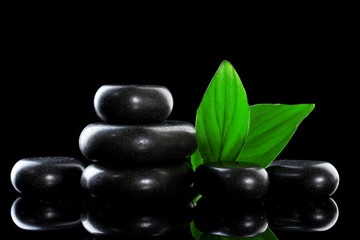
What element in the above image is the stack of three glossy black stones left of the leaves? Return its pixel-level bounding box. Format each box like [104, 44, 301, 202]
[79, 85, 196, 203]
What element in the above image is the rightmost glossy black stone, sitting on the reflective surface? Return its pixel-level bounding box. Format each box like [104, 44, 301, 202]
[266, 160, 339, 197]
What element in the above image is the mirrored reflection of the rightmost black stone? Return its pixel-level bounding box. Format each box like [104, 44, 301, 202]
[266, 198, 339, 232]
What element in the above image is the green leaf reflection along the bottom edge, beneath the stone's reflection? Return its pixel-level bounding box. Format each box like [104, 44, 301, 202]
[190, 224, 278, 240]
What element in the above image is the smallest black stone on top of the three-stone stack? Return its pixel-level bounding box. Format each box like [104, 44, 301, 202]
[94, 85, 173, 124]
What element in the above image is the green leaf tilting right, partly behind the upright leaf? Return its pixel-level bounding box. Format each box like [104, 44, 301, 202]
[236, 104, 315, 168]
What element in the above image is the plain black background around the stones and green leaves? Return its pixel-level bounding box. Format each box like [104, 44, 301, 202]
[1, 6, 358, 239]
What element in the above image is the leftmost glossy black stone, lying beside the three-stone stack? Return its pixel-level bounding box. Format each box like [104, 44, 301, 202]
[11, 157, 84, 197]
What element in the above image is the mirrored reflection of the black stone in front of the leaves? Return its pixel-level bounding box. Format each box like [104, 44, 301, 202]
[194, 198, 268, 238]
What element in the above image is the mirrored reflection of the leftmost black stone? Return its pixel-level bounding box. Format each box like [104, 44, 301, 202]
[11, 197, 80, 231]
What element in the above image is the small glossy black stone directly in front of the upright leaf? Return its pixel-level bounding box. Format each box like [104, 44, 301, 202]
[194, 162, 269, 201]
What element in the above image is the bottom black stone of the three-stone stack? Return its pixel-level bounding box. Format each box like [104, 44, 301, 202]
[81, 163, 193, 202]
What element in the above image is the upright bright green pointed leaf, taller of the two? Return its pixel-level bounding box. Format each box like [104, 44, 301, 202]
[195, 61, 250, 162]
